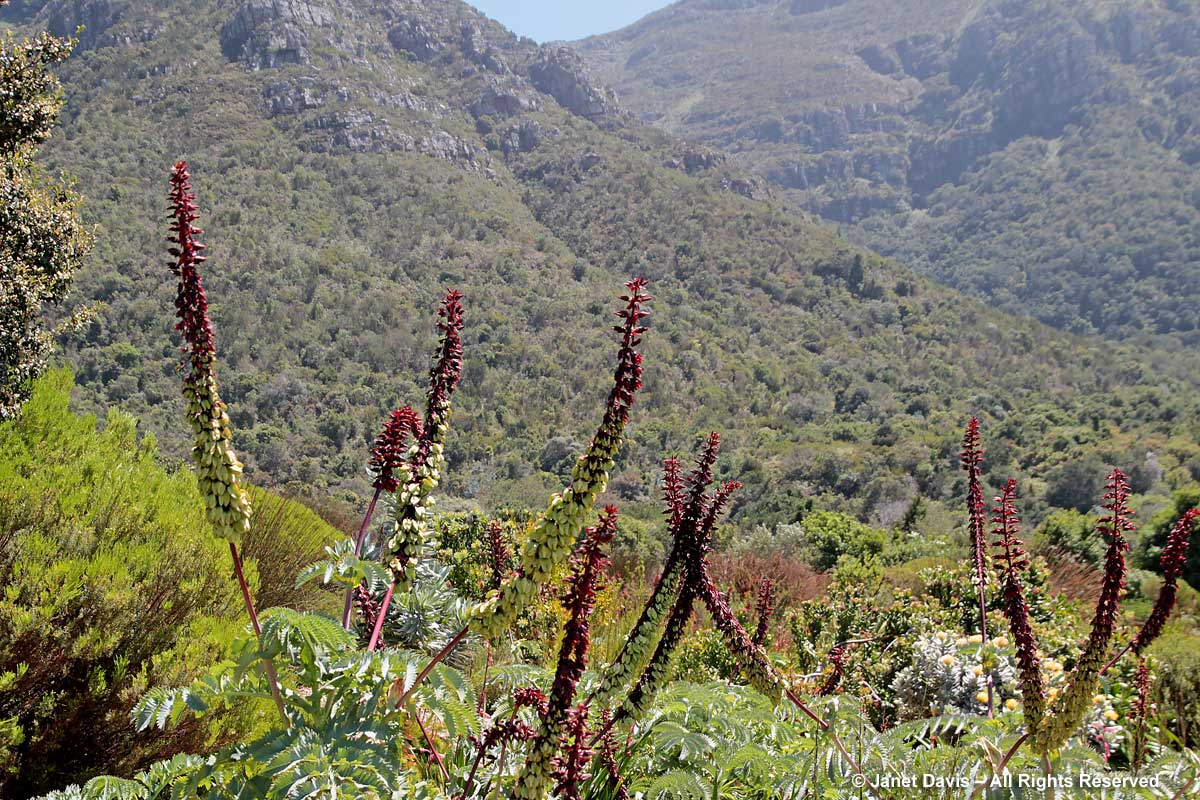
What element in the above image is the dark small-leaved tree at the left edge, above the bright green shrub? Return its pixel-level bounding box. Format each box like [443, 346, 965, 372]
[0, 7, 91, 420]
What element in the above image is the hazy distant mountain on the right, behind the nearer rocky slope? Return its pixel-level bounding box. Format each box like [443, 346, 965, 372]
[576, 0, 1200, 345]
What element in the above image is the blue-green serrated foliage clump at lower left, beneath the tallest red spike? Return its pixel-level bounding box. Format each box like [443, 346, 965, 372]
[60, 608, 465, 800]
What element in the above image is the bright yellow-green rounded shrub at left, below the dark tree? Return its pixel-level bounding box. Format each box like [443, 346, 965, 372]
[0, 371, 332, 796]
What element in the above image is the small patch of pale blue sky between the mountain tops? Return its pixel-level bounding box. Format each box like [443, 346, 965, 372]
[467, 0, 671, 42]
